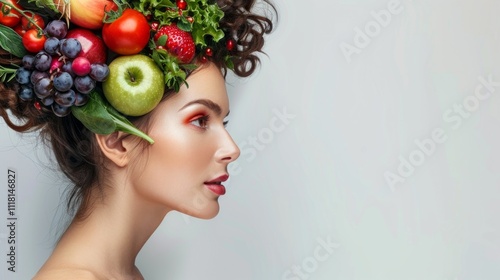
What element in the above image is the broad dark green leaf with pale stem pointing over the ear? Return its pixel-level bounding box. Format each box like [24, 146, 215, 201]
[71, 91, 154, 144]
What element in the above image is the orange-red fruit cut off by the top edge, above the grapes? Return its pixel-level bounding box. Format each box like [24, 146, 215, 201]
[54, 0, 118, 29]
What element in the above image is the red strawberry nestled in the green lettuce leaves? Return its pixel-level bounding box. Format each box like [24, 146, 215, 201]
[154, 23, 196, 63]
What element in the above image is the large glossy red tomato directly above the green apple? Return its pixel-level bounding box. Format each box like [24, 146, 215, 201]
[102, 9, 150, 55]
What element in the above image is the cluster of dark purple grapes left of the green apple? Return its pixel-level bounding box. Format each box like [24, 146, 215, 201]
[16, 20, 109, 117]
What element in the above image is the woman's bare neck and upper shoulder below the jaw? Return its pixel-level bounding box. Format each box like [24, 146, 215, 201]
[49, 175, 168, 279]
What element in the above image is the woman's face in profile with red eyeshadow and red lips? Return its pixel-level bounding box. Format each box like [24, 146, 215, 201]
[130, 64, 240, 219]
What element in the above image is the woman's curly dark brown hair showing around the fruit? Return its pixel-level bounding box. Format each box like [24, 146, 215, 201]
[0, 0, 277, 219]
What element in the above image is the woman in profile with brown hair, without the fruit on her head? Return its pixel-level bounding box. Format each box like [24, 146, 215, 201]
[0, 1, 272, 280]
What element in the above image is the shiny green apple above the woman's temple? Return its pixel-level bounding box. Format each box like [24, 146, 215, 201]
[102, 54, 165, 116]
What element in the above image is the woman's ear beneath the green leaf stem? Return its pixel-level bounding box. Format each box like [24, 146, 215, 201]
[95, 131, 132, 167]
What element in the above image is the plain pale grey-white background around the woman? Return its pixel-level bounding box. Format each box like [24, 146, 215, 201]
[0, 0, 500, 280]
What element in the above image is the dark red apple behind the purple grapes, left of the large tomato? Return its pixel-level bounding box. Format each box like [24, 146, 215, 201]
[66, 28, 107, 64]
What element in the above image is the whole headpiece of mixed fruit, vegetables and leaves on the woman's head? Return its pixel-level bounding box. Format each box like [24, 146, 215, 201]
[0, 0, 240, 143]
